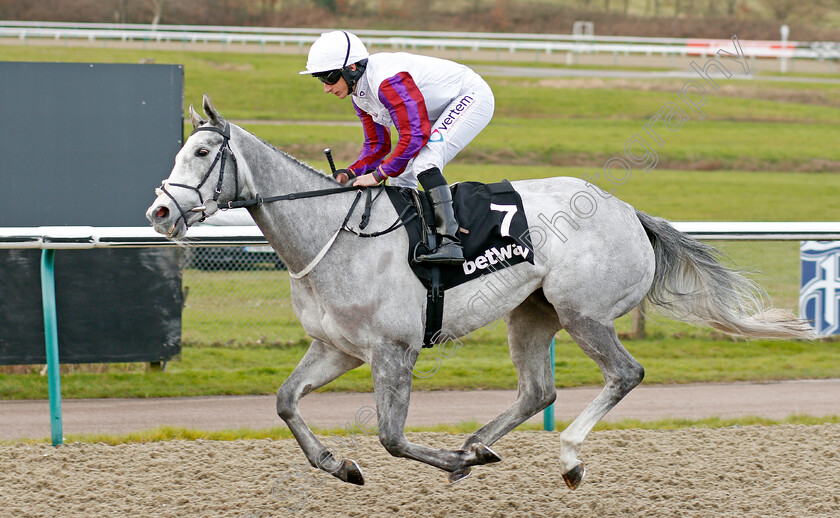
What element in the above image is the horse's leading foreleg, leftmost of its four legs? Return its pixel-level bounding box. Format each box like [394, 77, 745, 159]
[277, 340, 364, 485]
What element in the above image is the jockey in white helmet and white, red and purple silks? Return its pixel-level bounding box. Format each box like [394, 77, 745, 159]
[301, 31, 495, 264]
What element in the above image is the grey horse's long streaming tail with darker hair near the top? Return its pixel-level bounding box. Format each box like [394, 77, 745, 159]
[636, 210, 815, 339]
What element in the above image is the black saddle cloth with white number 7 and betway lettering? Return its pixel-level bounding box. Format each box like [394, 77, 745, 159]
[386, 180, 534, 289]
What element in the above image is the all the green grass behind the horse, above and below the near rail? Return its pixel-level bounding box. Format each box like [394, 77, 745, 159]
[0, 42, 840, 404]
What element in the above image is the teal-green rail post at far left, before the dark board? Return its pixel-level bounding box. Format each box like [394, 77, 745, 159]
[41, 249, 64, 446]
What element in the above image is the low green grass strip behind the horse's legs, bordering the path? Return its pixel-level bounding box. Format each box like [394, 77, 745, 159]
[0, 338, 840, 399]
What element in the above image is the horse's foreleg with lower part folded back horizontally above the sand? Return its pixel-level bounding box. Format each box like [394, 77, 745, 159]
[370, 347, 501, 482]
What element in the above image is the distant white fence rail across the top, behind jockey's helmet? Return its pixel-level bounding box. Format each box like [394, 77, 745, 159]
[0, 21, 840, 60]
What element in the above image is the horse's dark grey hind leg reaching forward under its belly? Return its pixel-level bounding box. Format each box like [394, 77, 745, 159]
[452, 290, 560, 478]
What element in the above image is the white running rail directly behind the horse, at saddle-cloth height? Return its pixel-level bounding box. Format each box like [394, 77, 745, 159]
[0, 221, 840, 249]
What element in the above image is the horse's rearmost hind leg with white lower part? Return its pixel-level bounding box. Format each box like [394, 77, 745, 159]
[560, 313, 645, 489]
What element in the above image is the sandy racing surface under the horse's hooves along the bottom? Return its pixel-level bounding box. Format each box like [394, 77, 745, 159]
[0, 424, 840, 518]
